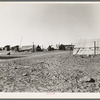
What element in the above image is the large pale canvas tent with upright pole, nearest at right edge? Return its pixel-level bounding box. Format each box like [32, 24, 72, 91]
[73, 39, 100, 55]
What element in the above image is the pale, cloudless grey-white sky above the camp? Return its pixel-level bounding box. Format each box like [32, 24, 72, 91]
[0, 2, 100, 46]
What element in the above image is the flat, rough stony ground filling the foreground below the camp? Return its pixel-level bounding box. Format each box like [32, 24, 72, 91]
[0, 51, 100, 92]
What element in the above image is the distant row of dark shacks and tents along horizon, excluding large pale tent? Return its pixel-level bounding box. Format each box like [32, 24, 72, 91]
[0, 44, 74, 52]
